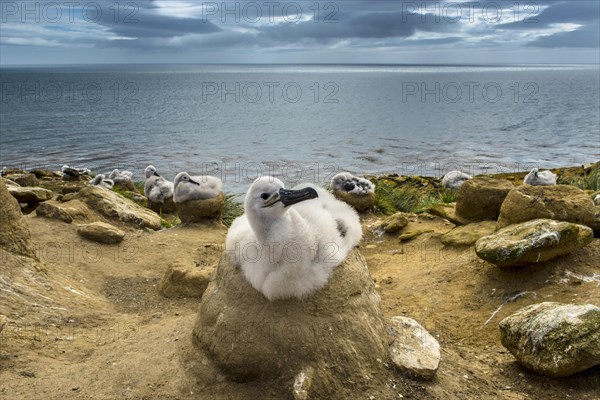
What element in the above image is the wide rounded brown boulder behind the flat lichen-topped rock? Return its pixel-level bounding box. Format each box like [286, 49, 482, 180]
[498, 185, 600, 229]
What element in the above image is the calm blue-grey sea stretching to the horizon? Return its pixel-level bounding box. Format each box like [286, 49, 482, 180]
[0, 65, 600, 192]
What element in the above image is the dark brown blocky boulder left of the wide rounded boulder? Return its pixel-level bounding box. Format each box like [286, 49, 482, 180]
[456, 176, 514, 222]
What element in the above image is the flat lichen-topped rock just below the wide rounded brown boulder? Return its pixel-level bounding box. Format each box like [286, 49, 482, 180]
[475, 219, 594, 266]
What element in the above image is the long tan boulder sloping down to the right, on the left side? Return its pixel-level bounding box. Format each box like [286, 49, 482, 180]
[77, 186, 161, 230]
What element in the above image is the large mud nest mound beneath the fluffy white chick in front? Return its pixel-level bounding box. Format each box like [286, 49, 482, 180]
[193, 249, 391, 399]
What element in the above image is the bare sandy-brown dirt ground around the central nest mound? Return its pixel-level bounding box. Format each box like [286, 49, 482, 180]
[0, 205, 600, 400]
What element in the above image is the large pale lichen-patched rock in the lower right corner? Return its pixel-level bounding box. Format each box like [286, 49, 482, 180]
[500, 302, 600, 377]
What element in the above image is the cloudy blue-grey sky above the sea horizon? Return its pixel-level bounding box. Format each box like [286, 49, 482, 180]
[0, 0, 600, 64]
